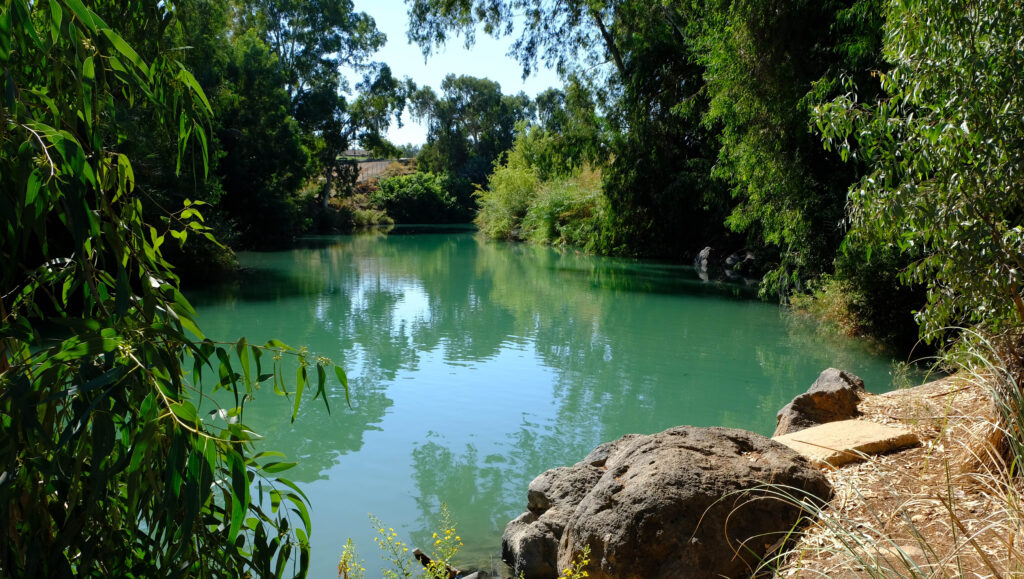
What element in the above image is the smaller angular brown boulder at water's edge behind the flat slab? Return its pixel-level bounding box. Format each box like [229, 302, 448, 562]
[772, 368, 867, 437]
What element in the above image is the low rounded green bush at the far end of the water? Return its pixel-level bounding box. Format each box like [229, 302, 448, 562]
[370, 173, 468, 223]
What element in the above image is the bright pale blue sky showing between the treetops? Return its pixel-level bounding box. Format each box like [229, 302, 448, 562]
[353, 0, 561, 144]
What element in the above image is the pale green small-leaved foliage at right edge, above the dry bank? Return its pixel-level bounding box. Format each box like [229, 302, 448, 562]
[816, 0, 1024, 337]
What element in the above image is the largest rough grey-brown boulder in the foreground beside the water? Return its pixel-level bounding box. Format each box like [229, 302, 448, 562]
[502, 426, 831, 579]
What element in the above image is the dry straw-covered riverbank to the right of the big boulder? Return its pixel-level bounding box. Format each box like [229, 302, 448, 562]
[778, 376, 1024, 577]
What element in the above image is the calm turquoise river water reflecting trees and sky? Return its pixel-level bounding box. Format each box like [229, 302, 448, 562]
[189, 230, 909, 578]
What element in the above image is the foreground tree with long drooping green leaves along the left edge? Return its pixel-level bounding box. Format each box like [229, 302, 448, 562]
[0, 0, 344, 577]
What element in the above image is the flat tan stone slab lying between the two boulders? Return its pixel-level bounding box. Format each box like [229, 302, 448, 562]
[772, 420, 920, 466]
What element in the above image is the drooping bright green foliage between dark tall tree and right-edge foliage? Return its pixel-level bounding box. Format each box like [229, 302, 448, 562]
[697, 0, 879, 296]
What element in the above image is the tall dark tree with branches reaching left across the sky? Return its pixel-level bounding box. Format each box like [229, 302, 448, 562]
[410, 0, 725, 257]
